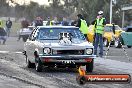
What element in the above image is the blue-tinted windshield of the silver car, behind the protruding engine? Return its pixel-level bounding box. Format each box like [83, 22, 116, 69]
[38, 28, 85, 40]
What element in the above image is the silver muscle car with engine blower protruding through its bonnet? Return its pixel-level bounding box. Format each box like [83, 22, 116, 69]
[24, 26, 96, 72]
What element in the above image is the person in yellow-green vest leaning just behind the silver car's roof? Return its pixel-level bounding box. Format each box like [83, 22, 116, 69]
[76, 14, 88, 40]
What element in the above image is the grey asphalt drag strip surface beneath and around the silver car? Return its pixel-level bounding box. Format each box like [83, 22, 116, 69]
[0, 52, 132, 88]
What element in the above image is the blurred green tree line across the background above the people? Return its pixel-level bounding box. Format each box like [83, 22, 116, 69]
[0, 0, 132, 26]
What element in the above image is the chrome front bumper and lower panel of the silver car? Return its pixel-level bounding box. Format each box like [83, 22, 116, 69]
[39, 55, 96, 64]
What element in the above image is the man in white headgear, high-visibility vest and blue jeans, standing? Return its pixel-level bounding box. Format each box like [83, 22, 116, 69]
[92, 11, 106, 57]
